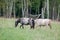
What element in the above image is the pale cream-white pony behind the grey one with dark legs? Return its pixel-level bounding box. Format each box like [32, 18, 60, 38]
[35, 19, 51, 29]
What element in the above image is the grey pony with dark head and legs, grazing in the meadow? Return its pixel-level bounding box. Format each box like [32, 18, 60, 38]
[15, 18, 35, 28]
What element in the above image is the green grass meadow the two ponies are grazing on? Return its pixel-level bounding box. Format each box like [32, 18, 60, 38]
[0, 18, 60, 40]
